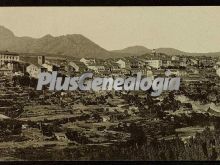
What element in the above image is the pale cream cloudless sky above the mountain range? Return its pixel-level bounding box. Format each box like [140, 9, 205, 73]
[0, 6, 220, 52]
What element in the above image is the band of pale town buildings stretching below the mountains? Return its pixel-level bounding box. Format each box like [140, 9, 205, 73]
[0, 51, 220, 84]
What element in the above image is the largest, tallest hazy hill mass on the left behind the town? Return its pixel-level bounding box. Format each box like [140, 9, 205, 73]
[0, 26, 130, 58]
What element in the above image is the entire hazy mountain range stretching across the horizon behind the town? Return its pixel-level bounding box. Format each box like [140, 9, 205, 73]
[0, 26, 220, 58]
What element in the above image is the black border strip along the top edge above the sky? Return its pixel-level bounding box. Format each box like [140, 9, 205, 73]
[0, 0, 220, 7]
